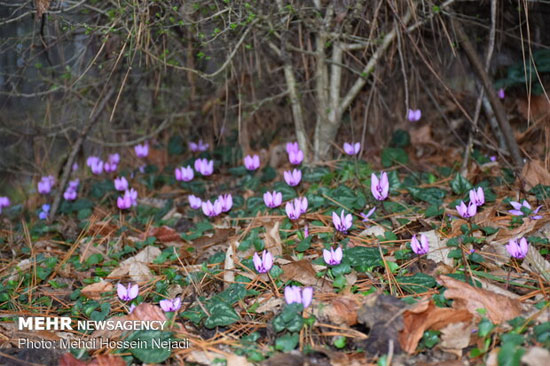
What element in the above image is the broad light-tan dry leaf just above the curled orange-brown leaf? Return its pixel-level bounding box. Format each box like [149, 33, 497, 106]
[437, 276, 522, 324]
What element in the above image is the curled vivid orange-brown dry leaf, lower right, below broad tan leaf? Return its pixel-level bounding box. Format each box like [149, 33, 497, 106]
[399, 298, 473, 353]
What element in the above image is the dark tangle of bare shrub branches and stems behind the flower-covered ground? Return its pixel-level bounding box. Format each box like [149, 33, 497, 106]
[0, 0, 550, 194]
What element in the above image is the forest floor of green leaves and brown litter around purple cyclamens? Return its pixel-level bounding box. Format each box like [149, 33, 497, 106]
[0, 131, 550, 365]
